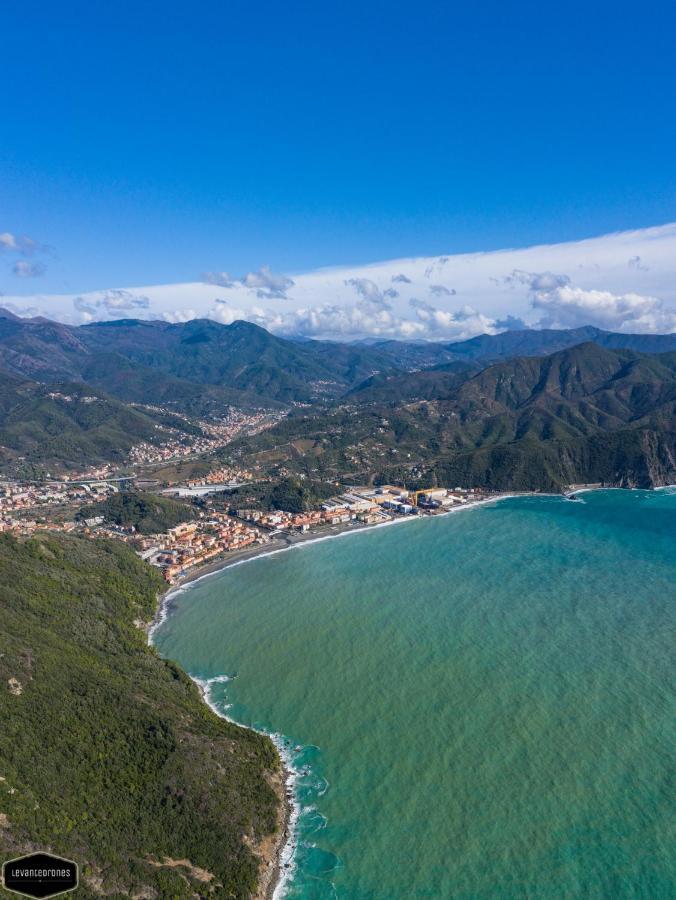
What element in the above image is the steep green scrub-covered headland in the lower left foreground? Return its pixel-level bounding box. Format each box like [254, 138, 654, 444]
[0, 535, 278, 898]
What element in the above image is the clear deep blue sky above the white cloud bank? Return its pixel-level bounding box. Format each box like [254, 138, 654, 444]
[0, 2, 676, 310]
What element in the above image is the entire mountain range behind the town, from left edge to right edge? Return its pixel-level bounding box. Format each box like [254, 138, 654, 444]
[0, 311, 676, 488]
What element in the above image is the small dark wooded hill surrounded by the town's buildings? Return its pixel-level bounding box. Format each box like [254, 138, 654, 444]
[78, 491, 197, 534]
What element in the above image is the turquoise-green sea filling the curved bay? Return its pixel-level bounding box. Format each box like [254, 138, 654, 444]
[155, 489, 676, 900]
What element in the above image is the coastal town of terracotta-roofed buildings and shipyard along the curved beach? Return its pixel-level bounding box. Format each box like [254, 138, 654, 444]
[0, 466, 488, 584]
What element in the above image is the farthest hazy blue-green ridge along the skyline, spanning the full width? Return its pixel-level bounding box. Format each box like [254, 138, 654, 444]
[0, 310, 676, 410]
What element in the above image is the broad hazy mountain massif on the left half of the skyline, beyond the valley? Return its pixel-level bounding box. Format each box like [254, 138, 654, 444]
[0, 310, 401, 411]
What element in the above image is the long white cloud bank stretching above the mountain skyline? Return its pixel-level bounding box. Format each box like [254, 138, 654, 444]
[5, 224, 676, 341]
